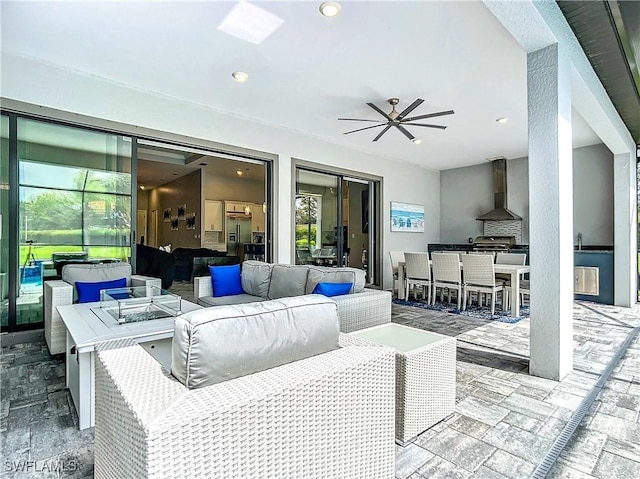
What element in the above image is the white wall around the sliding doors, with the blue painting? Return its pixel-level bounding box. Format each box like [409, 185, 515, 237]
[1, 52, 440, 288]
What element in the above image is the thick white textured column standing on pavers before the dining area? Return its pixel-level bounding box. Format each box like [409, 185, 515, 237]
[528, 44, 573, 381]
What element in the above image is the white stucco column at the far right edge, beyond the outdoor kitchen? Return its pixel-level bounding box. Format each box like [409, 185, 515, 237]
[613, 152, 638, 307]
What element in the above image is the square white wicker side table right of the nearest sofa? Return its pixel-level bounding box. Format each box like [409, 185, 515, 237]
[346, 323, 456, 443]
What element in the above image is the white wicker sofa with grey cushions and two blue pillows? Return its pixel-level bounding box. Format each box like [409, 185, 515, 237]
[193, 261, 391, 333]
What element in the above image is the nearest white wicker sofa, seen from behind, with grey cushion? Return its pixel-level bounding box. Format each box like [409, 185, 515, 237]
[95, 295, 395, 479]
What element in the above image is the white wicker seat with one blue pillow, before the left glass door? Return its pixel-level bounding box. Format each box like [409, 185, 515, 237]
[44, 262, 162, 354]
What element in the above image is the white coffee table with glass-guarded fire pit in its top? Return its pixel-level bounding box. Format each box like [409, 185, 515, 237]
[58, 300, 202, 429]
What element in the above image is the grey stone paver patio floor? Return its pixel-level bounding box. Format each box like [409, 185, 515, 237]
[0, 303, 640, 479]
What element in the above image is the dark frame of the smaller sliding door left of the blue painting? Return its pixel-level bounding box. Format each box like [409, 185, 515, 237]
[291, 158, 383, 288]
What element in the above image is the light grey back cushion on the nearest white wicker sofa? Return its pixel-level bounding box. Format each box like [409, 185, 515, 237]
[171, 295, 340, 389]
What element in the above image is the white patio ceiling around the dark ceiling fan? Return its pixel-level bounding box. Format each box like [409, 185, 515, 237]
[0, 1, 600, 170]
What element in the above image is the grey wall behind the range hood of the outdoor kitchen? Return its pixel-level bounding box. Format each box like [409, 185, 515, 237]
[440, 144, 613, 245]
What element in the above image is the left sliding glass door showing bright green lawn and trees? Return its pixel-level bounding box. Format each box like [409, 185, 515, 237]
[8, 118, 132, 330]
